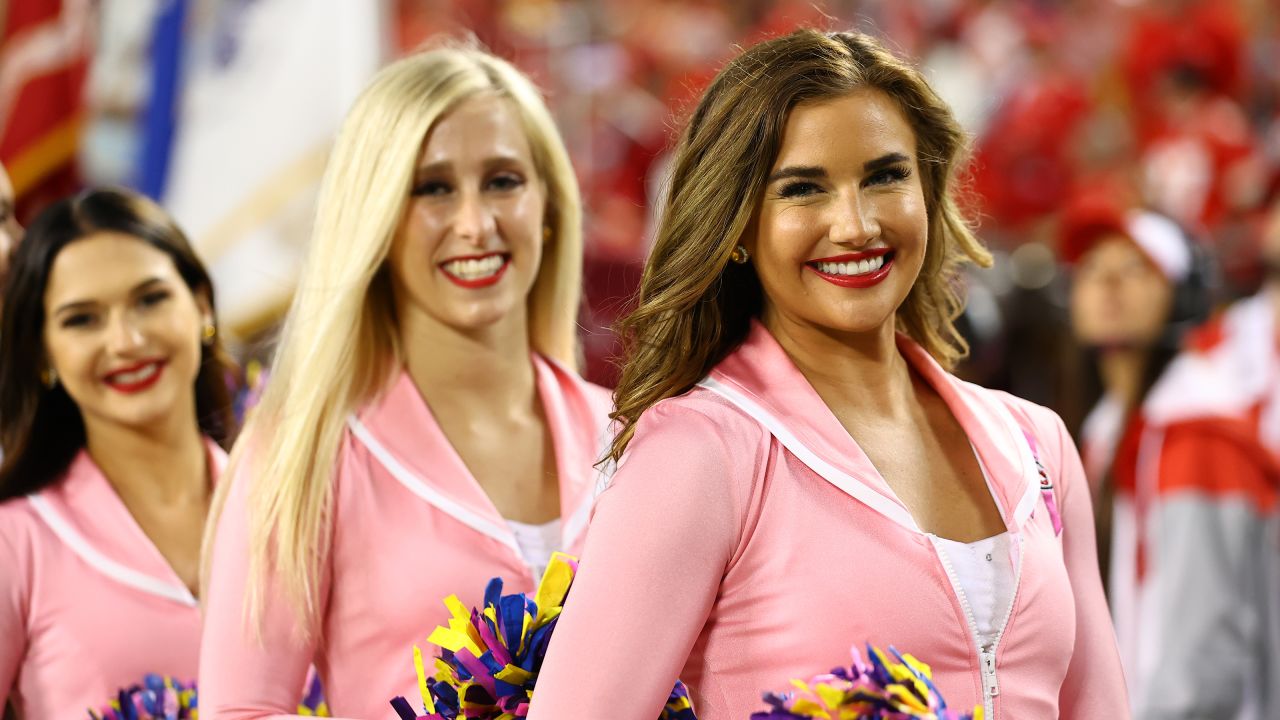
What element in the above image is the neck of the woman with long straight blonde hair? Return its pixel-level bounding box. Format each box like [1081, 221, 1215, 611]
[401, 307, 536, 415]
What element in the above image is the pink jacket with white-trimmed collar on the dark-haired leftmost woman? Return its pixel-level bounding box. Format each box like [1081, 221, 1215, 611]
[0, 442, 227, 720]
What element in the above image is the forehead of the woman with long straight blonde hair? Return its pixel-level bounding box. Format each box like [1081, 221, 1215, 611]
[419, 94, 531, 165]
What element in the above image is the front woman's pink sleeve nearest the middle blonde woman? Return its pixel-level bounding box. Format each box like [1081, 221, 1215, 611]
[529, 398, 763, 720]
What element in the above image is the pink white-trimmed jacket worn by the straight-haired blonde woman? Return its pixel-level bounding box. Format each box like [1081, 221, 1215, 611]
[200, 356, 612, 720]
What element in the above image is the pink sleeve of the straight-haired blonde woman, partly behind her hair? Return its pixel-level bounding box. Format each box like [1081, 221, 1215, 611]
[198, 453, 348, 720]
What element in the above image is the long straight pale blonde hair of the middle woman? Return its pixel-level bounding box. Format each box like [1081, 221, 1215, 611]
[204, 46, 582, 633]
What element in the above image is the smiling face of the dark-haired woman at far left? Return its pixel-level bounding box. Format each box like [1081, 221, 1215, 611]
[45, 232, 212, 432]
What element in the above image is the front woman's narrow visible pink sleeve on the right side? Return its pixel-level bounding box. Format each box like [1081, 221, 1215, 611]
[1038, 407, 1129, 720]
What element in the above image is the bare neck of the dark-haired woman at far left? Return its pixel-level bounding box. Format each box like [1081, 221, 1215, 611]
[84, 401, 210, 502]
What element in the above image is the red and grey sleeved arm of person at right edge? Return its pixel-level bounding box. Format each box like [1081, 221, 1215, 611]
[1135, 432, 1274, 720]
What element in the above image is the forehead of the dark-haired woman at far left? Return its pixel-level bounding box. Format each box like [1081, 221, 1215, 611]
[45, 232, 178, 305]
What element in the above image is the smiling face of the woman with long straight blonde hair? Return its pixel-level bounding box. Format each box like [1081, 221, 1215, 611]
[390, 95, 547, 333]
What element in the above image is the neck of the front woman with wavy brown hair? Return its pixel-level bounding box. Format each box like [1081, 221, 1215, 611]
[762, 313, 914, 416]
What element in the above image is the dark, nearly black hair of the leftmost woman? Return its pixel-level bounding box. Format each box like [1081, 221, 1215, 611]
[0, 188, 234, 501]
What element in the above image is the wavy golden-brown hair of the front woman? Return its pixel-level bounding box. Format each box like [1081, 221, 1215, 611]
[609, 29, 991, 460]
